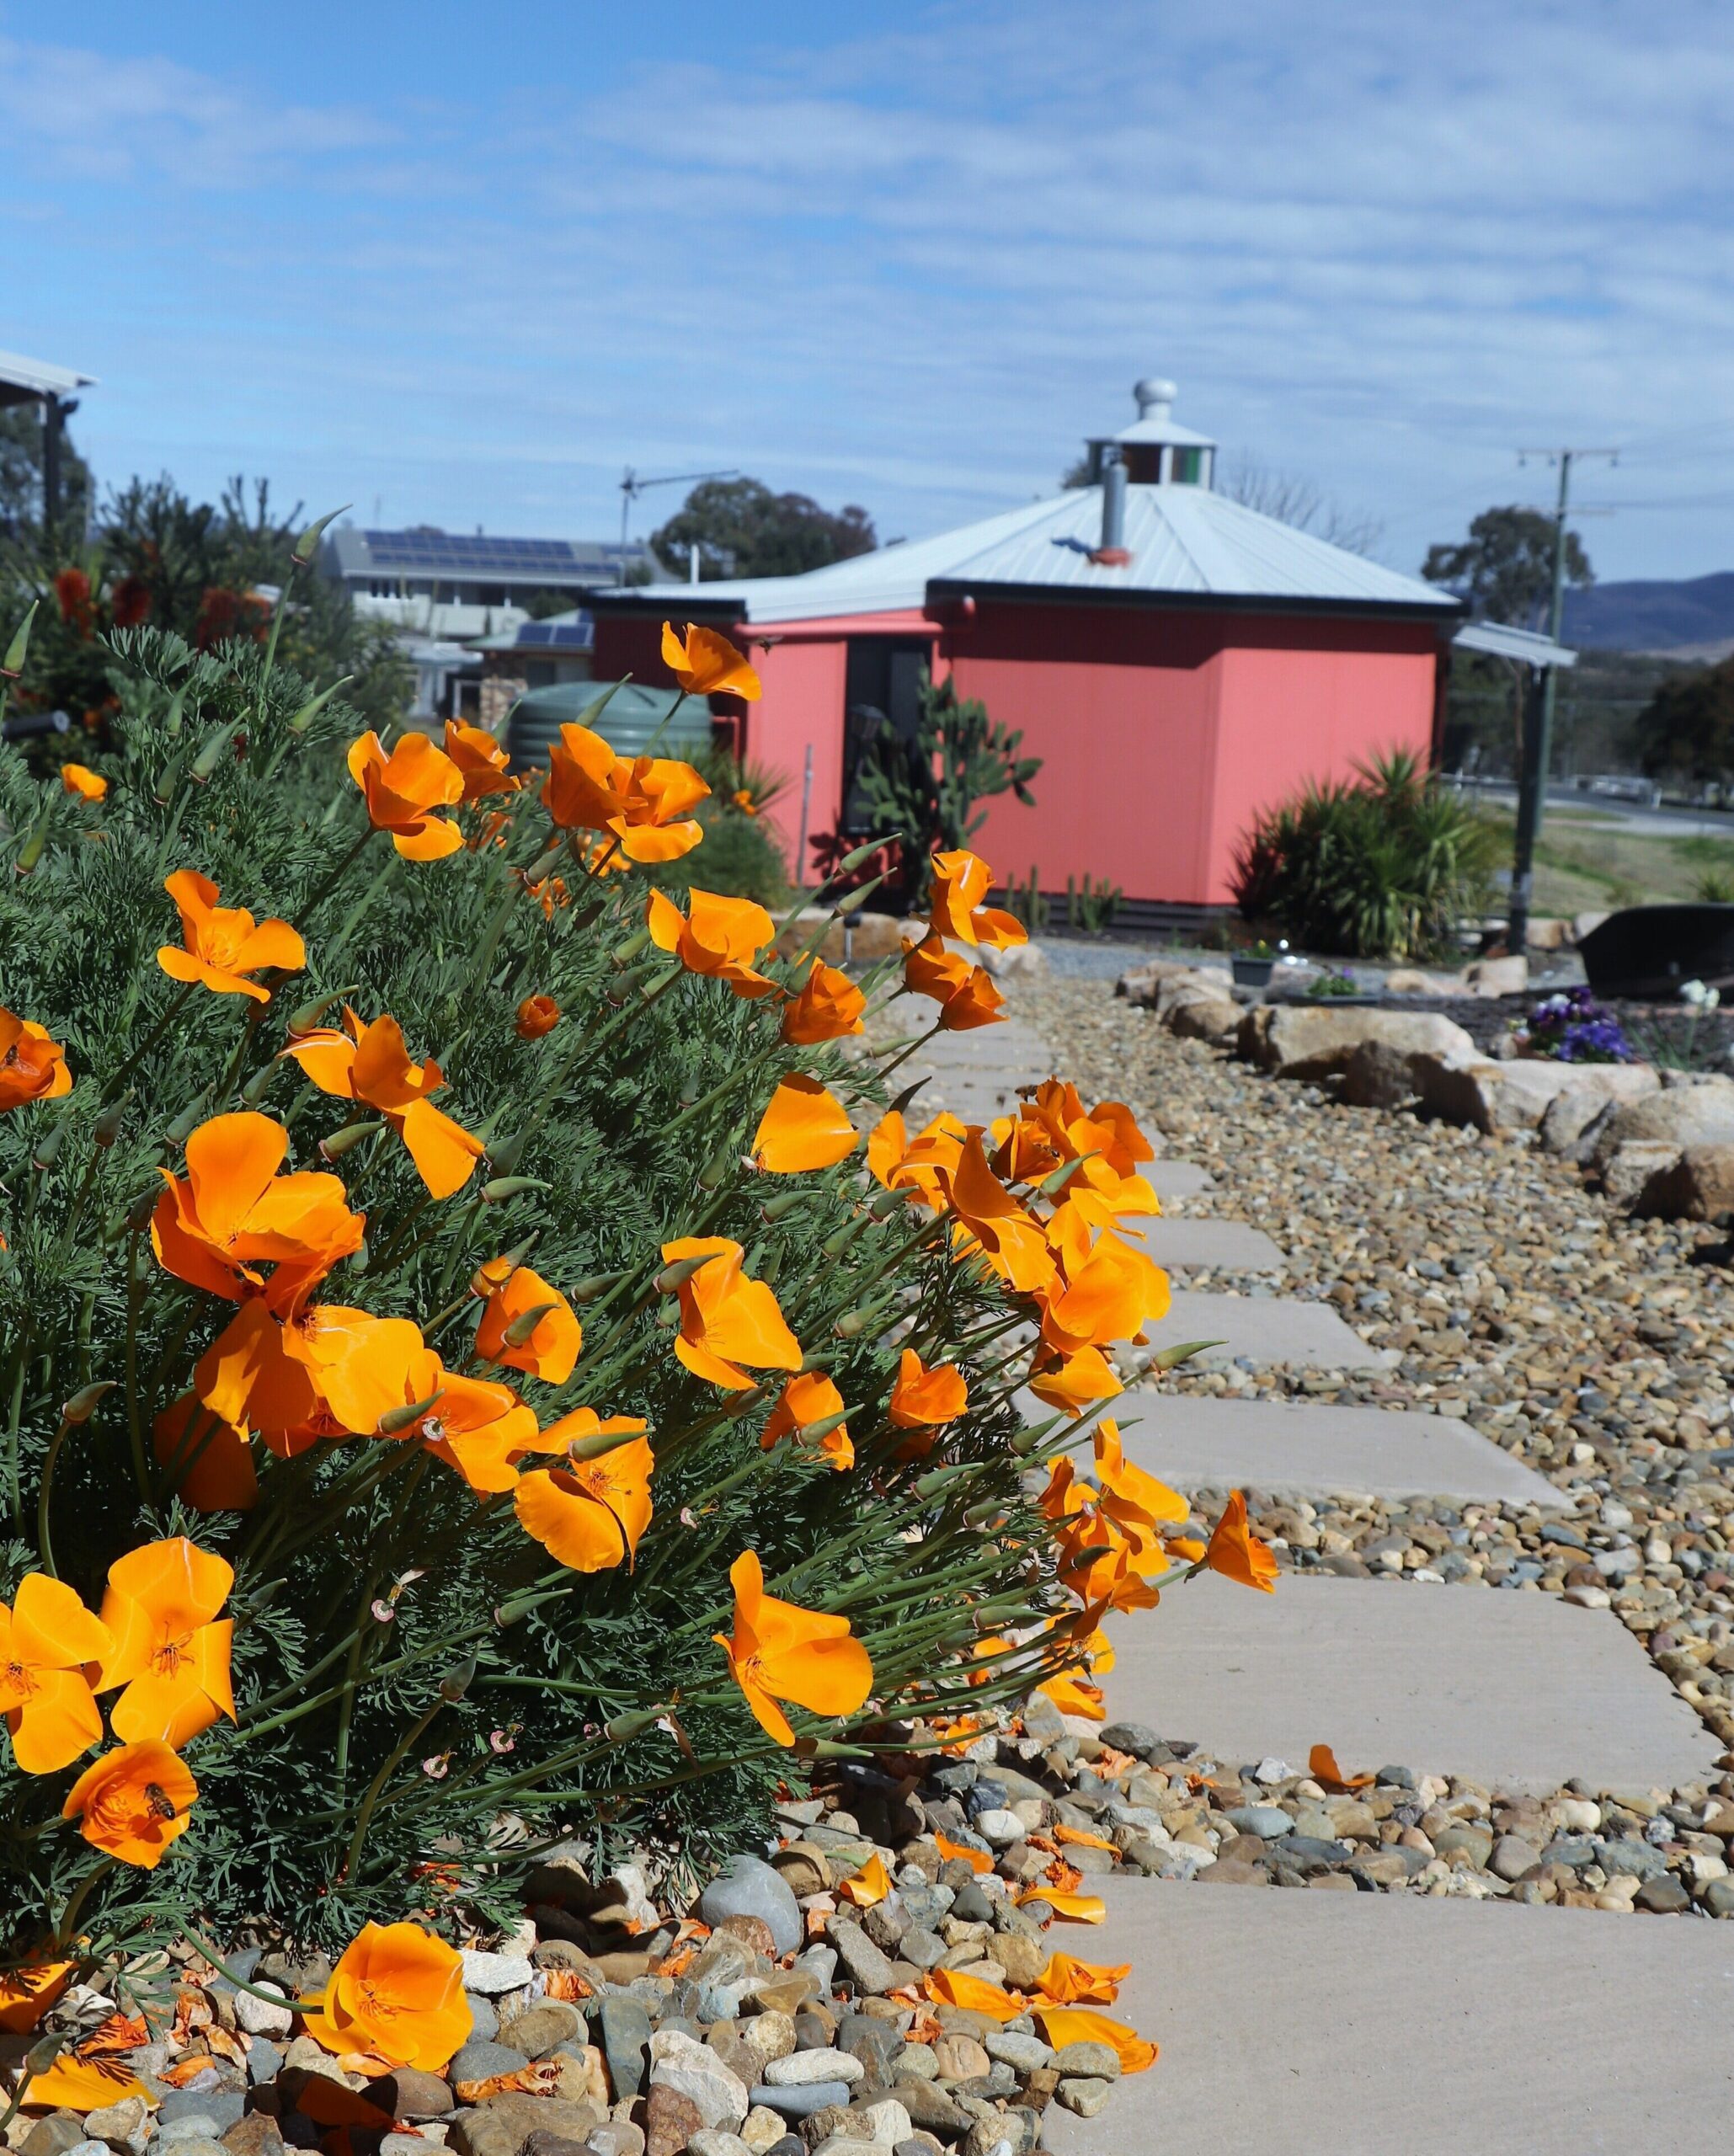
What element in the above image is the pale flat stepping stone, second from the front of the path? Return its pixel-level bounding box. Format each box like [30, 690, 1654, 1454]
[1107, 1574, 1734, 1793]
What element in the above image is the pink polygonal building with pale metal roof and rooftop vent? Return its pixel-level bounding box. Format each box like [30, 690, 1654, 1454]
[589, 382, 1462, 919]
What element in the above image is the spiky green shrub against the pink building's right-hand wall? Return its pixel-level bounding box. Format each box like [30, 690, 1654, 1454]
[1234, 750, 1501, 958]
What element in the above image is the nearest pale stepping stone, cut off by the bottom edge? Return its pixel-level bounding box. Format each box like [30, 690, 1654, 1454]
[1042, 1888, 1734, 2156]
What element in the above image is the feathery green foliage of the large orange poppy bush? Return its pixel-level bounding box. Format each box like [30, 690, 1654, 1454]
[0, 590, 1112, 1967]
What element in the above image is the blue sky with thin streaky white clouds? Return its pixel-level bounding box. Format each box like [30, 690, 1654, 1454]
[0, 0, 1734, 576]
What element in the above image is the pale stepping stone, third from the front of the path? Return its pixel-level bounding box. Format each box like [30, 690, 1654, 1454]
[1115, 1390, 1568, 1512]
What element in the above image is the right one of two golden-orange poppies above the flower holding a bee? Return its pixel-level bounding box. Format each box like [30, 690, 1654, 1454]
[97, 1535, 235, 1747]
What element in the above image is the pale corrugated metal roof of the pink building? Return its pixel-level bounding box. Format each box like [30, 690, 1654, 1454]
[595, 483, 1462, 621]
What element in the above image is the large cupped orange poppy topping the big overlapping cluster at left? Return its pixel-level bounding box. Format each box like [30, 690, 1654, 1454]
[151, 1113, 366, 1310]
